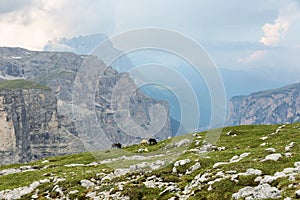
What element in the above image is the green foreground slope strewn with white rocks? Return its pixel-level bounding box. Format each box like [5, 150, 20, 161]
[0, 123, 300, 200]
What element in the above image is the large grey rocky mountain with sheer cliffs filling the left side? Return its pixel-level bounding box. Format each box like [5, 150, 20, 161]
[0, 48, 172, 163]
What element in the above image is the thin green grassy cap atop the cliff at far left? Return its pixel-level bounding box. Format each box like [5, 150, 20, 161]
[0, 79, 51, 90]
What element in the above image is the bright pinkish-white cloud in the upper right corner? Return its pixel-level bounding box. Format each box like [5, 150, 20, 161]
[260, 1, 300, 46]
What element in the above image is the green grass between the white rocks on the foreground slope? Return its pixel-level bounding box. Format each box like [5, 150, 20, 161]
[0, 123, 300, 199]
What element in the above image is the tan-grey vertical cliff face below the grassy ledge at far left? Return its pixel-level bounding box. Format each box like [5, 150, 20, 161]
[0, 89, 83, 164]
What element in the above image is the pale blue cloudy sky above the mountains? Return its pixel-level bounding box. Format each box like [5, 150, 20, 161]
[0, 0, 300, 82]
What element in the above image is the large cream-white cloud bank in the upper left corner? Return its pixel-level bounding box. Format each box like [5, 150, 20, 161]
[0, 0, 113, 50]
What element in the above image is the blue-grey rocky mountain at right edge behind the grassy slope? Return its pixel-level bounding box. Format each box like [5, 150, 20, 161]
[226, 83, 300, 125]
